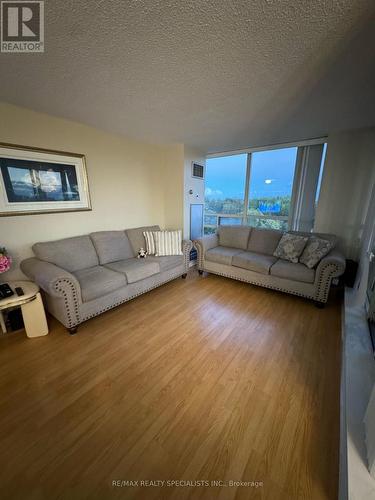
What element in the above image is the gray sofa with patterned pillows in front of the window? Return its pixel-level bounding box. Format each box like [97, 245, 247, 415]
[194, 226, 345, 305]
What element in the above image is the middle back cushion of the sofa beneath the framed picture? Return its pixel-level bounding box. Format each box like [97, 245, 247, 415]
[90, 231, 135, 264]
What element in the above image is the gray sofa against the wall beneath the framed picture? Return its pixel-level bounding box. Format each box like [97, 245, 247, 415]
[21, 226, 192, 333]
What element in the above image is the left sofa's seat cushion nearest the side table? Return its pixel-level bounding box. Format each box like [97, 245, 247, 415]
[73, 266, 126, 302]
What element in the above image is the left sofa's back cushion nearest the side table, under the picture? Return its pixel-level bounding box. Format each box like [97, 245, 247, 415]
[33, 235, 99, 272]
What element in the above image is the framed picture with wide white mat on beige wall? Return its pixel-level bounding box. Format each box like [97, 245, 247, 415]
[0, 143, 91, 217]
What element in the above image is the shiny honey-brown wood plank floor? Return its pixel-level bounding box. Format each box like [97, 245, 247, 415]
[0, 271, 341, 500]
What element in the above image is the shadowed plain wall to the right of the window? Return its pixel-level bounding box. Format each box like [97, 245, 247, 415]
[314, 128, 375, 259]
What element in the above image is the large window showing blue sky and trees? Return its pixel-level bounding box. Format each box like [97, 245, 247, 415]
[204, 143, 326, 234]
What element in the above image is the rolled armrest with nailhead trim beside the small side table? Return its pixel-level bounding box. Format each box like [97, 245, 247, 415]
[21, 257, 82, 303]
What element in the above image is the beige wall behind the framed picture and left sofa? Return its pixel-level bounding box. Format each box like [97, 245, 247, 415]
[0, 103, 183, 279]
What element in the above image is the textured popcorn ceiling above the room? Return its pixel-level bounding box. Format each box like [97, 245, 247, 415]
[0, 0, 375, 152]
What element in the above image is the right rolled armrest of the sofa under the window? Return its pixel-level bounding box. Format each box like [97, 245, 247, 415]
[315, 249, 346, 302]
